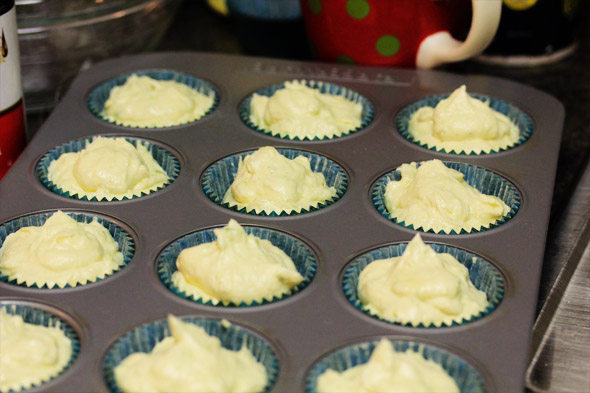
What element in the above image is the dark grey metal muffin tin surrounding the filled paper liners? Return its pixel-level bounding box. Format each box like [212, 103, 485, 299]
[0, 52, 564, 393]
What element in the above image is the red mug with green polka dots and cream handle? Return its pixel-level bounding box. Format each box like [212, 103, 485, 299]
[300, 0, 502, 68]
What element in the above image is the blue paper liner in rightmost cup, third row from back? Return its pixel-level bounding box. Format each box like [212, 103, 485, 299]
[342, 242, 504, 328]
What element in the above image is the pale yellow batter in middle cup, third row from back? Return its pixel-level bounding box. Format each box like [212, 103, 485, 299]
[172, 219, 303, 304]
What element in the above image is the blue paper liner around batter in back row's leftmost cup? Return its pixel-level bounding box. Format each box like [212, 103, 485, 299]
[88, 69, 219, 129]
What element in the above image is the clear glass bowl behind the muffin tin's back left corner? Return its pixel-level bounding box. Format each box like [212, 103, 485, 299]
[16, 0, 181, 112]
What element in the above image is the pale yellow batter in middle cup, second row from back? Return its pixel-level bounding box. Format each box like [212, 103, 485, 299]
[223, 146, 336, 214]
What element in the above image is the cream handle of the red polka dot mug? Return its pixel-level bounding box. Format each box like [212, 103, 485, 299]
[416, 0, 502, 68]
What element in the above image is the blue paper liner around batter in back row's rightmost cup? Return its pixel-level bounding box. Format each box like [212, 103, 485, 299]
[395, 93, 533, 155]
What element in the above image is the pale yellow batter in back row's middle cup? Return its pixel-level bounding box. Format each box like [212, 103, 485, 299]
[250, 80, 363, 139]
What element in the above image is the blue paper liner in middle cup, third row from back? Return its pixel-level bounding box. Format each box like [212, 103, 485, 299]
[156, 225, 317, 307]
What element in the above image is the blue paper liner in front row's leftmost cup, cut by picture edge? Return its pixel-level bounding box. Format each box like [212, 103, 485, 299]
[0, 300, 80, 392]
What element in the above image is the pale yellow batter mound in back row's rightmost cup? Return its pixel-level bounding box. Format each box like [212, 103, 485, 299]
[408, 85, 520, 153]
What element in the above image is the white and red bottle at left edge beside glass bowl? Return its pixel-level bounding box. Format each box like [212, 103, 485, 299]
[0, 1, 26, 179]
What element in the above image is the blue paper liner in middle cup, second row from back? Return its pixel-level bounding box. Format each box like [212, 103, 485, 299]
[201, 148, 348, 217]
